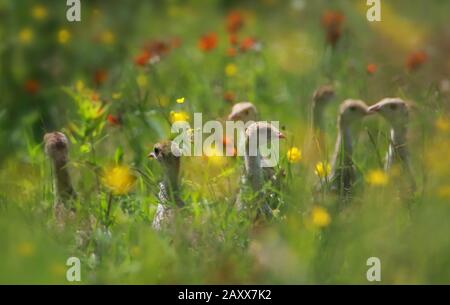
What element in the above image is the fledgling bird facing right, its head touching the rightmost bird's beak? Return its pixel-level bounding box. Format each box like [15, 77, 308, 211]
[328, 99, 370, 196]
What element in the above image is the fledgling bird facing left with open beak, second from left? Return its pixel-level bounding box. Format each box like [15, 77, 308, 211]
[148, 141, 185, 231]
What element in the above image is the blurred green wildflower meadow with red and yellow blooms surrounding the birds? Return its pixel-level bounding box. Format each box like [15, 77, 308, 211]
[0, 0, 450, 284]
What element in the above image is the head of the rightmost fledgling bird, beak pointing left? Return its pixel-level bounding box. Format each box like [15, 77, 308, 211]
[369, 98, 409, 126]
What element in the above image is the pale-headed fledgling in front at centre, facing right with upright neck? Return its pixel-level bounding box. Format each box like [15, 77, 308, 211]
[236, 122, 284, 217]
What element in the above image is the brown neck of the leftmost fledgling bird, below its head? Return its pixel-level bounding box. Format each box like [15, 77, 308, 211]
[52, 156, 75, 201]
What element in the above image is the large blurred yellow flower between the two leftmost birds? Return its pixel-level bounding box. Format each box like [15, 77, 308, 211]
[102, 165, 136, 195]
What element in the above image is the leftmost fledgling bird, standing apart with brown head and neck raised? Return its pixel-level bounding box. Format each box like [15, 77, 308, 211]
[44, 131, 77, 226]
